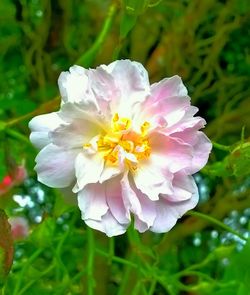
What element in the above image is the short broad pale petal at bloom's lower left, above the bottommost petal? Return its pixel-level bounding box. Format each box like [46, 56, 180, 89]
[78, 183, 108, 221]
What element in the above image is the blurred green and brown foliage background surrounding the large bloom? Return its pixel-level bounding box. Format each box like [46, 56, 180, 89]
[0, 0, 250, 295]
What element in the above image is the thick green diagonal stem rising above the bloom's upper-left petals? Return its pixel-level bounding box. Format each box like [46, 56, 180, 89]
[76, 4, 117, 67]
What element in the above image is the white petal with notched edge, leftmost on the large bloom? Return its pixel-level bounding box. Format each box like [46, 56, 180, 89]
[29, 113, 64, 149]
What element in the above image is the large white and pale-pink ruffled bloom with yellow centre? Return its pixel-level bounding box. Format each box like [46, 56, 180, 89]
[29, 60, 211, 236]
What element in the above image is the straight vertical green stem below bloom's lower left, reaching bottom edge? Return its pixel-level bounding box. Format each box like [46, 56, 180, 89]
[87, 228, 95, 295]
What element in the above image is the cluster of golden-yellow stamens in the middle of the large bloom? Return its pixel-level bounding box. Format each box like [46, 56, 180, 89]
[85, 113, 151, 170]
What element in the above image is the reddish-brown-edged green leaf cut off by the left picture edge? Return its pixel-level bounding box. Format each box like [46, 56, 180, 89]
[0, 209, 14, 286]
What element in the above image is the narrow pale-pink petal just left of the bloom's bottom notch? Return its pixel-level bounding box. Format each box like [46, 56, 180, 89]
[105, 177, 130, 224]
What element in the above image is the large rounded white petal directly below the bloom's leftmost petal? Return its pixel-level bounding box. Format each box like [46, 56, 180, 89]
[35, 144, 78, 188]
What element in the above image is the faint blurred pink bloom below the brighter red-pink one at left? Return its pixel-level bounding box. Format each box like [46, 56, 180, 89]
[9, 217, 29, 240]
